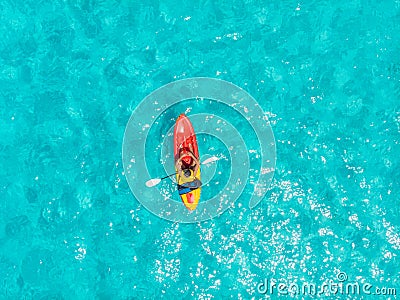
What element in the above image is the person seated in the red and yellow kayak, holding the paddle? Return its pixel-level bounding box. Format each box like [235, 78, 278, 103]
[175, 148, 201, 194]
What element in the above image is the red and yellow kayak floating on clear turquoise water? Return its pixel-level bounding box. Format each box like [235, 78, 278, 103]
[174, 114, 201, 210]
